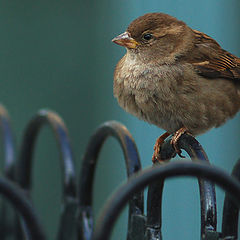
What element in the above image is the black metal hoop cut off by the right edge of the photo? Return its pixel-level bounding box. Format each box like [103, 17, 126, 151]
[222, 159, 240, 240]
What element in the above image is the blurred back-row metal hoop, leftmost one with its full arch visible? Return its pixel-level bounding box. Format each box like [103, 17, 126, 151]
[17, 110, 77, 240]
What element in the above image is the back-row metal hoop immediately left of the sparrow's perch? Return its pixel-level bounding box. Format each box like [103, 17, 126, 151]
[79, 121, 143, 240]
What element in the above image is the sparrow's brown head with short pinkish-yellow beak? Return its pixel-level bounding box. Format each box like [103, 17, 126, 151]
[112, 13, 193, 62]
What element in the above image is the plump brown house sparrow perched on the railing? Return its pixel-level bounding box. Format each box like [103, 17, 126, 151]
[112, 13, 240, 162]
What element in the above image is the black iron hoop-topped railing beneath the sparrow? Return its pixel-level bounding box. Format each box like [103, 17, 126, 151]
[0, 103, 240, 240]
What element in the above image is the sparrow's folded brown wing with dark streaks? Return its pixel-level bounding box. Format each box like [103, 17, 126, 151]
[190, 30, 240, 80]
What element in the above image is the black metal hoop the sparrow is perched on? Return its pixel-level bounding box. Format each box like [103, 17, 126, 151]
[147, 133, 218, 239]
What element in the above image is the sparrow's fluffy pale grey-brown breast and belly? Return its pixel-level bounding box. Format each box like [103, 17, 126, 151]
[114, 54, 240, 135]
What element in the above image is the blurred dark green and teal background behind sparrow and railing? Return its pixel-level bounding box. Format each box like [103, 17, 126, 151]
[0, 0, 240, 240]
